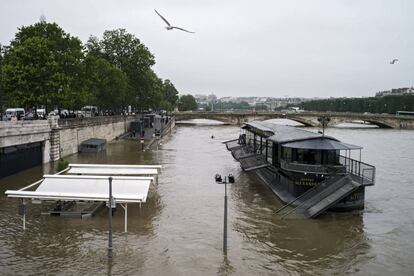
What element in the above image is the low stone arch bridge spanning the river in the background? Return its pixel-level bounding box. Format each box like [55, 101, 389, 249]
[176, 112, 414, 129]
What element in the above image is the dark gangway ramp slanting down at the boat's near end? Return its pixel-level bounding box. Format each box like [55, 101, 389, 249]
[282, 175, 361, 218]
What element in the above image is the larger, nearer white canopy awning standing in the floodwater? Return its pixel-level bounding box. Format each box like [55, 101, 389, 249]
[6, 175, 154, 203]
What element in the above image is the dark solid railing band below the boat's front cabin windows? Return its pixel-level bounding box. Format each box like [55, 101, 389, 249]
[280, 159, 346, 174]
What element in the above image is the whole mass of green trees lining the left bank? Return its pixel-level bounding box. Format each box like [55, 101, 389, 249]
[0, 20, 178, 110]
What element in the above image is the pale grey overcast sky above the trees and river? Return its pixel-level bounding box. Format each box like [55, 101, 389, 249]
[0, 0, 414, 97]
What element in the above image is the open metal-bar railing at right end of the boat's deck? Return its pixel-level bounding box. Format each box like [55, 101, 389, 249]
[339, 155, 375, 186]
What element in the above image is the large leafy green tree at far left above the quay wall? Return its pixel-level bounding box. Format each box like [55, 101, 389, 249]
[2, 20, 85, 108]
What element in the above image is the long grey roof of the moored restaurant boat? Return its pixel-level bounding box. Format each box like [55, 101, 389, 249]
[242, 121, 362, 150]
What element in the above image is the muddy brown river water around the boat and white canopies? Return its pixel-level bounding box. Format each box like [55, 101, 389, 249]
[0, 121, 414, 275]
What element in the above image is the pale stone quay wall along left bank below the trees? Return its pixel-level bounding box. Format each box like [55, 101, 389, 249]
[0, 116, 134, 163]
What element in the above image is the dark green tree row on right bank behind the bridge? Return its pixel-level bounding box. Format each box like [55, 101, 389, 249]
[301, 94, 414, 114]
